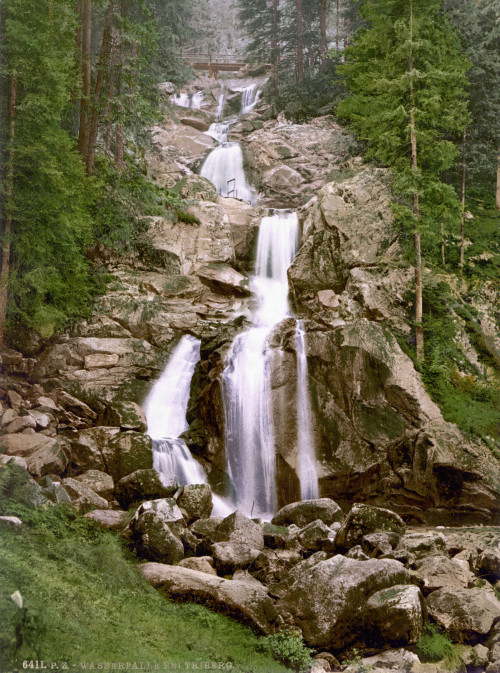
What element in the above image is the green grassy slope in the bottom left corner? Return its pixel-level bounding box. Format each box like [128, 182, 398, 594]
[0, 494, 286, 673]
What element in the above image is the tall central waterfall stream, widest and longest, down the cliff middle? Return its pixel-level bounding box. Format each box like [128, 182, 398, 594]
[222, 211, 298, 517]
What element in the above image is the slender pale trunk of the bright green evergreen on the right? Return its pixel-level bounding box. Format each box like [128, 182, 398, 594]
[408, 0, 424, 361]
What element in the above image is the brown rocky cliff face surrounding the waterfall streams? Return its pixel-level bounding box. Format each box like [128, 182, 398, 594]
[4, 83, 500, 523]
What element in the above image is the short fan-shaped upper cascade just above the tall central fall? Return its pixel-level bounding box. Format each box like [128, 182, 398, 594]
[200, 143, 257, 203]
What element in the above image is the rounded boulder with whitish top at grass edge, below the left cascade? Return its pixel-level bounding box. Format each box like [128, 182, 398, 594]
[125, 498, 184, 563]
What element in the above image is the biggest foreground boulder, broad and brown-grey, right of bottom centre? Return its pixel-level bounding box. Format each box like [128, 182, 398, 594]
[277, 555, 412, 650]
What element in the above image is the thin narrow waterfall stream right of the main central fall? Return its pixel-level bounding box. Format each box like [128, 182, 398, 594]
[295, 320, 319, 500]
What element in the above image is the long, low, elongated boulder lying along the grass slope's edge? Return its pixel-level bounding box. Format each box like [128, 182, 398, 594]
[138, 563, 277, 634]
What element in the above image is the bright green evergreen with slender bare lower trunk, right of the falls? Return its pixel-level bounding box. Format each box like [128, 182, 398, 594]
[338, 0, 468, 359]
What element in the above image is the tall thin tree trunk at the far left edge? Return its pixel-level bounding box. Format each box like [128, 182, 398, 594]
[0, 74, 17, 349]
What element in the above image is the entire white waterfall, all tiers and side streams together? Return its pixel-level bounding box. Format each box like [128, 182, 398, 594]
[144, 83, 318, 518]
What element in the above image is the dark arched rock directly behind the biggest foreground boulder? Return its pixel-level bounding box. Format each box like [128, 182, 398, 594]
[336, 504, 406, 550]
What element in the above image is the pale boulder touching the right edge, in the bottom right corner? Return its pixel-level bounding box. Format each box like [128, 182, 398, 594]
[427, 587, 500, 644]
